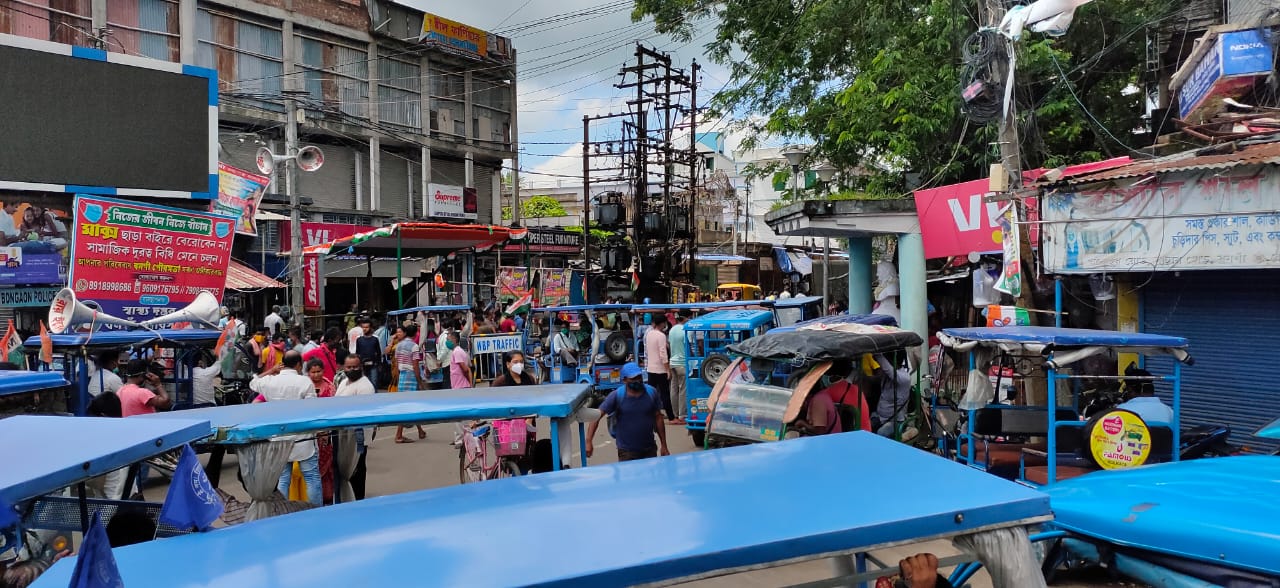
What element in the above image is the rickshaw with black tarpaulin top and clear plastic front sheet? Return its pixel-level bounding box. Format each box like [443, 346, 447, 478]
[705, 323, 923, 447]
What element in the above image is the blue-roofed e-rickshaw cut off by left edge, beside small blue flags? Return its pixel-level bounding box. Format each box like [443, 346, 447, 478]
[0, 409, 209, 561]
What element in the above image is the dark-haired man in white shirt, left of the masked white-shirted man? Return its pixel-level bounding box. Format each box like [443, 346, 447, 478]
[248, 351, 324, 506]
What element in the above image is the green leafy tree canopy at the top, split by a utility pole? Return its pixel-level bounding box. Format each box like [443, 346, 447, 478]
[634, 0, 1179, 193]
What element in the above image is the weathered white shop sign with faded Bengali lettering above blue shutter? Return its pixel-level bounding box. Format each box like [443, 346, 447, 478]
[1042, 172, 1280, 273]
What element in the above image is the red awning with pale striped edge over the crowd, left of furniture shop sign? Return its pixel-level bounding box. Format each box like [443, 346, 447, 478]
[307, 223, 509, 257]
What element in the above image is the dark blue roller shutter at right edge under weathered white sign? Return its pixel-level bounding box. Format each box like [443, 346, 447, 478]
[1142, 269, 1280, 448]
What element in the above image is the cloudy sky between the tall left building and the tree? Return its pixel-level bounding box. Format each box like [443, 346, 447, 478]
[399, 0, 735, 186]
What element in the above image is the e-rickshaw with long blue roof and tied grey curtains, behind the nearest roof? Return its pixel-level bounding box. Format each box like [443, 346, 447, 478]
[158, 384, 590, 520]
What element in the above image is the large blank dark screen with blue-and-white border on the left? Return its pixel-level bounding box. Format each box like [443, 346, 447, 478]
[0, 35, 218, 200]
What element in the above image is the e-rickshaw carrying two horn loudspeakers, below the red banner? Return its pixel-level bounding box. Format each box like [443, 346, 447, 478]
[23, 328, 221, 416]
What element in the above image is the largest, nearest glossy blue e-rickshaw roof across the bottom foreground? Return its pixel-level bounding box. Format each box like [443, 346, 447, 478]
[36, 432, 1050, 588]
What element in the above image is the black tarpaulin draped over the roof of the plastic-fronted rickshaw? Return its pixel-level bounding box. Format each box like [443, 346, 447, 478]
[728, 325, 923, 360]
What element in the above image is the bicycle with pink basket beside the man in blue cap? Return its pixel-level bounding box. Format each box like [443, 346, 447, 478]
[453, 419, 529, 484]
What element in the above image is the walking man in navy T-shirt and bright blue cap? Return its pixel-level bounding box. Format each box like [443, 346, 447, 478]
[586, 361, 671, 461]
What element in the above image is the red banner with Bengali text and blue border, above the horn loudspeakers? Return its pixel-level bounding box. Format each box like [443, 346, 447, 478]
[68, 196, 236, 320]
